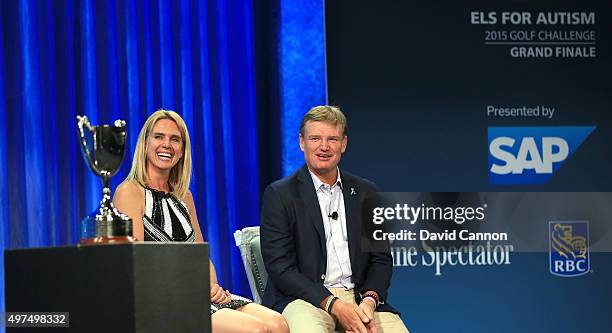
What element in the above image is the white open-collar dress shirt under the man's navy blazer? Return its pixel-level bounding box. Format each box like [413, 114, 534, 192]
[308, 170, 355, 289]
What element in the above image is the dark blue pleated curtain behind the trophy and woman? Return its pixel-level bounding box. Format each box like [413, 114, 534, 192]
[0, 0, 260, 311]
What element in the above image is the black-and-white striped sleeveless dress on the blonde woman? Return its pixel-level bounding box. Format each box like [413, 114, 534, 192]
[142, 187, 252, 314]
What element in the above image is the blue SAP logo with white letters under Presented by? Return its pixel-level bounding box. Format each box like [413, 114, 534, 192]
[488, 126, 595, 185]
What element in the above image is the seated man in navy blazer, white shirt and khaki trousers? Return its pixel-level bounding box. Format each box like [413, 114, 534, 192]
[261, 106, 408, 333]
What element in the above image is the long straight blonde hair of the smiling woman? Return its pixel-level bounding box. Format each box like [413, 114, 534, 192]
[125, 109, 191, 199]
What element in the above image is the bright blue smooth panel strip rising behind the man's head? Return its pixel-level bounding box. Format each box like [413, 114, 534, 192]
[275, 0, 326, 176]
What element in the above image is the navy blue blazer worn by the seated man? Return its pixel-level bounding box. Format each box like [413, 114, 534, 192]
[260, 165, 398, 313]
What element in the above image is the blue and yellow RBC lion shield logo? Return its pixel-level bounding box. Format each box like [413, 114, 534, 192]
[548, 221, 590, 277]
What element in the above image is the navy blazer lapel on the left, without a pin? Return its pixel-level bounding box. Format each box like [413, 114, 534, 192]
[298, 166, 327, 262]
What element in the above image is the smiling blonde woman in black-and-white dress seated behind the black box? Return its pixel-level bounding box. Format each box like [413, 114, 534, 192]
[113, 110, 289, 333]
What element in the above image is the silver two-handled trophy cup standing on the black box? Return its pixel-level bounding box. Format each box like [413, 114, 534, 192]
[77, 116, 134, 244]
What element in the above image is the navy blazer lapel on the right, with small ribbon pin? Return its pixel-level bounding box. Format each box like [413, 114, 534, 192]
[340, 171, 361, 276]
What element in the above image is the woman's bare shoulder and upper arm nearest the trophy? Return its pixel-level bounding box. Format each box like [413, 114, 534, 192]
[113, 181, 145, 241]
